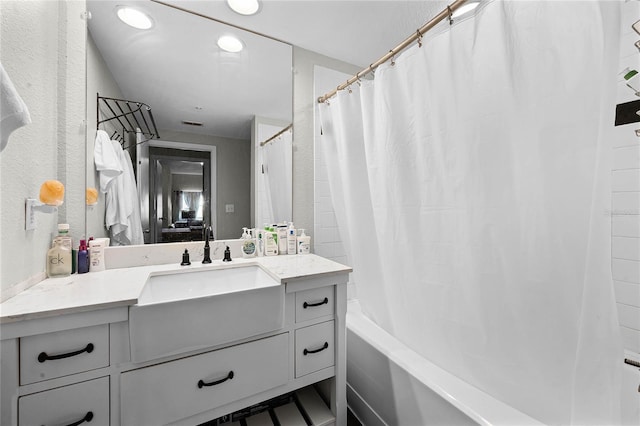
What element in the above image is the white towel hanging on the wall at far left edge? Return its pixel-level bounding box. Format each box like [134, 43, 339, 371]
[0, 63, 31, 152]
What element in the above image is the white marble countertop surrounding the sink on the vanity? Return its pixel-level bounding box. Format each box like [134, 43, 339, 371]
[0, 254, 351, 324]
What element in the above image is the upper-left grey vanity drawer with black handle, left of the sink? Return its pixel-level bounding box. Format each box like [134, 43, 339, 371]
[20, 324, 109, 385]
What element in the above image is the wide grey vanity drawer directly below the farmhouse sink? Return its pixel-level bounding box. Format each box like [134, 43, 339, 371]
[120, 333, 289, 425]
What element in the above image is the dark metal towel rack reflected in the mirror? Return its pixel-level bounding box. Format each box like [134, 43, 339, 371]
[96, 93, 160, 148]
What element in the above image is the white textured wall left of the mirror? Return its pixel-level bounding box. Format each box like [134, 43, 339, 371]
[0, 0, 86, 299]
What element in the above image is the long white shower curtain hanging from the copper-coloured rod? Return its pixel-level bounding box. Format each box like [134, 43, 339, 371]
[319, 0, 622, 424]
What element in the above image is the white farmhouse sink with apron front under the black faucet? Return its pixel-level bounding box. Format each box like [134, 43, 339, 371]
[129, 265, 284, 362]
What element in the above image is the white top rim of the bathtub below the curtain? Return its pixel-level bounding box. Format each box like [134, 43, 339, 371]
[346, 300, 543, 425]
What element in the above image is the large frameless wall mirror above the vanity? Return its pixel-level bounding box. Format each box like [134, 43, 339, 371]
[86, 0, 293, 244]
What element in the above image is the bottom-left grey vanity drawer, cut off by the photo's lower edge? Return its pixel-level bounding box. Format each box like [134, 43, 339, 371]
[18, 377, 109, 426]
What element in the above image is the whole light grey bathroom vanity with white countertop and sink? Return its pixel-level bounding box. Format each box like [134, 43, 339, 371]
[0, 250, 351, 426]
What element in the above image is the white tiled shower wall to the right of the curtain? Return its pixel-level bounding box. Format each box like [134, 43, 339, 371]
[611, 1, 640, 353]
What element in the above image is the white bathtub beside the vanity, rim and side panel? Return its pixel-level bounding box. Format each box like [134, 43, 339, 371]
[347, 300, 542, 426]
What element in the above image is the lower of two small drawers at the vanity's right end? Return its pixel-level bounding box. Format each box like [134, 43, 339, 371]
[295, 321, 335, 377]
